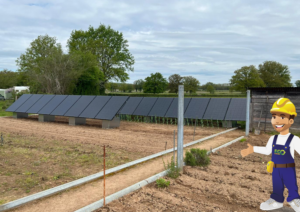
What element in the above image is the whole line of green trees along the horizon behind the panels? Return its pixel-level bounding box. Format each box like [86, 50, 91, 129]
[0, 24, 300, 95]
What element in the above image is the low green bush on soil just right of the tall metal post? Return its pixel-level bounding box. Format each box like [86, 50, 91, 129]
[184, 149, 210, 167]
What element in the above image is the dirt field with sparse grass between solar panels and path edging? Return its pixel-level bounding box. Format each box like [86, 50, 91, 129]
[0, 116, 236, 204]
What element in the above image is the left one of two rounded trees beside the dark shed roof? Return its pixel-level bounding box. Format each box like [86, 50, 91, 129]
[230, 65, 265, 92]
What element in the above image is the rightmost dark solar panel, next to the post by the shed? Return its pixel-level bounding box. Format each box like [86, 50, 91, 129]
[225, 98, 247, 121]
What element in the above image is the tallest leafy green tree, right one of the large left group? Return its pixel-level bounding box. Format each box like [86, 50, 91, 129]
[68, 24, 134, 94]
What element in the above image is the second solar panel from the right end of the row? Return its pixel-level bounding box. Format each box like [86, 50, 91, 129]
[203, 98, 231, 120]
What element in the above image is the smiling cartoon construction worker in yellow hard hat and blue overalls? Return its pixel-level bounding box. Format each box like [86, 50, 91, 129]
[241, 98, 300, 212]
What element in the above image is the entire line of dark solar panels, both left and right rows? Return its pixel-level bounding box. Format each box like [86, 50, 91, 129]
[6, 94, 246, 121]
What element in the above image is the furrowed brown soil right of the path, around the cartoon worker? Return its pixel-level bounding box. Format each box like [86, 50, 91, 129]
[97, 133, 300, 212]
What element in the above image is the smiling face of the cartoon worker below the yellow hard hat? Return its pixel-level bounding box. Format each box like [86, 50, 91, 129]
[271, 112, 294, 132]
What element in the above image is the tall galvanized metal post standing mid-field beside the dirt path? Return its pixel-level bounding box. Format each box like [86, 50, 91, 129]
[177, 85, 184, 171]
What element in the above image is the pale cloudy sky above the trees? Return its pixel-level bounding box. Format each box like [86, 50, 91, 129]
[0, 0, 300, 84]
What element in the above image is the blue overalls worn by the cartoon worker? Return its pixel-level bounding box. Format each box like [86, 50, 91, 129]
[271, 134, 300, 203]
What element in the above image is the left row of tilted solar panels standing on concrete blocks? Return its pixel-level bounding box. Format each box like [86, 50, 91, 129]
[6, 94, 128, 120]
